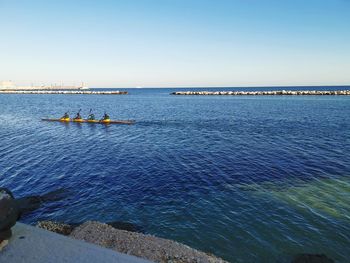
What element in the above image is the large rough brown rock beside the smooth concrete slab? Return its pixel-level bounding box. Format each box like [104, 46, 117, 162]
[70, 222, 225, 263]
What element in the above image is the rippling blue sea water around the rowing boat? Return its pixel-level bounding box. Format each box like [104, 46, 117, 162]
[0, 87, 350, 262]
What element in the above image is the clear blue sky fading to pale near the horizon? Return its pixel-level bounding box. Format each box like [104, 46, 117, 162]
[0, 0, 350, 87]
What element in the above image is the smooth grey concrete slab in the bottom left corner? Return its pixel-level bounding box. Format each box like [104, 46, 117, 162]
[0, 223, 151, 263]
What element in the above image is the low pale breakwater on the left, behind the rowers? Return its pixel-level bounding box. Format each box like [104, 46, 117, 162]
[0, 90, 128, 95]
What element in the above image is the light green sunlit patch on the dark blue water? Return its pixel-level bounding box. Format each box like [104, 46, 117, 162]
[238, 177, 350, 221]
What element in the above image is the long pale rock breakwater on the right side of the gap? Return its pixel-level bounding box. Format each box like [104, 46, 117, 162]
[170, 90, 350, 96]
